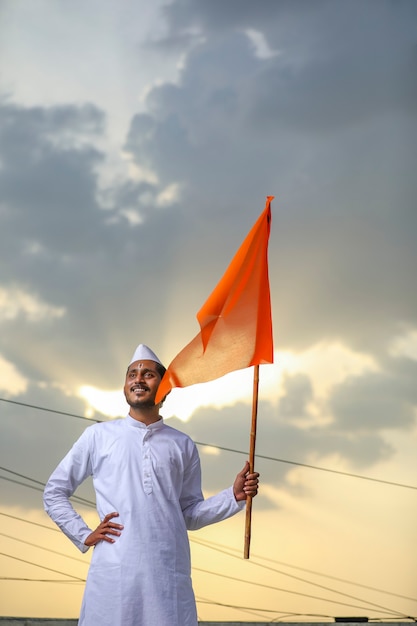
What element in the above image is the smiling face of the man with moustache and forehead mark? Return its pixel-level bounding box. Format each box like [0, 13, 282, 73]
[123, 361, 161, 408]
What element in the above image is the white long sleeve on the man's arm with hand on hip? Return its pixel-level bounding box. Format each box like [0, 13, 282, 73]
[43, 429, 92, 552]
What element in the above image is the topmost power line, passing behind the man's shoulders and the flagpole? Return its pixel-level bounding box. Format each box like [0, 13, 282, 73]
[0, 398, 417, 490]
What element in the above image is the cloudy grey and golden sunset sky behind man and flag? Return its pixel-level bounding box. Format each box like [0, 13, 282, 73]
[0, 0, 417, 622]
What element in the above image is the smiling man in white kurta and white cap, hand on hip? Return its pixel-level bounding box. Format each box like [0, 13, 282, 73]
[44, 344, 259, 626]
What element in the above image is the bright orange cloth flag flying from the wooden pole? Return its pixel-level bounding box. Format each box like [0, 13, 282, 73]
[156, 196, 274, 403]
